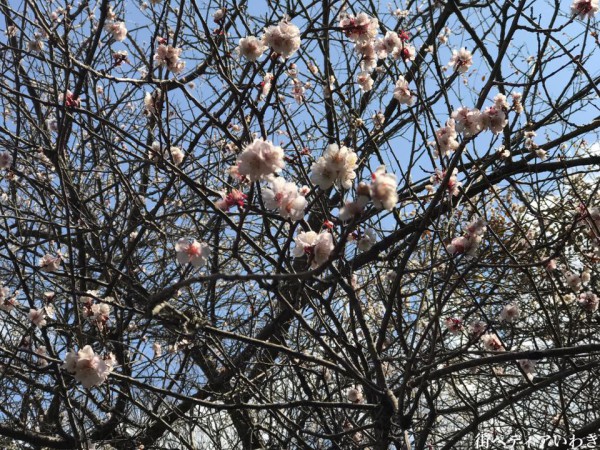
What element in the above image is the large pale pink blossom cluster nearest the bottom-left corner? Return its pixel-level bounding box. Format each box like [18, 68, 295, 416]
[62, 345, 116, 389]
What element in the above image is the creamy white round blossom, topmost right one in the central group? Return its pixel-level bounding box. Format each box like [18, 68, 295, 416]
[310, 144, 358, 189]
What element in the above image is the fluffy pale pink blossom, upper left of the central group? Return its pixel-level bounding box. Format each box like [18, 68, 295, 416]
[237, 139, 285, 181]
